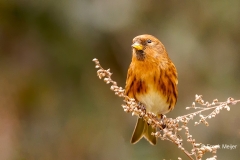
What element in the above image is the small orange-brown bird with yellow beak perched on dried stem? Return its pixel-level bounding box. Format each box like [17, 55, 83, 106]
[125, 34, 178, 145]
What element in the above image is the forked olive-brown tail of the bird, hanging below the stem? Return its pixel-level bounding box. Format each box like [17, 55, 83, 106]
[131, 118, 157, 145]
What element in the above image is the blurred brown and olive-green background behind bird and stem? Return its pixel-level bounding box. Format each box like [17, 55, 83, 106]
[0, 0, 240, 160]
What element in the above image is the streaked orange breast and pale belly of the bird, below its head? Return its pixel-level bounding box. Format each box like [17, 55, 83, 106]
[125, 58, 177, 115]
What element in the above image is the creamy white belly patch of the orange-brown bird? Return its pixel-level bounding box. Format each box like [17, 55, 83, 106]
[137, 89, 169, 115]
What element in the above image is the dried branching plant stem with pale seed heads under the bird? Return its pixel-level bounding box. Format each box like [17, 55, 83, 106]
[93, 58, 240, 160]
